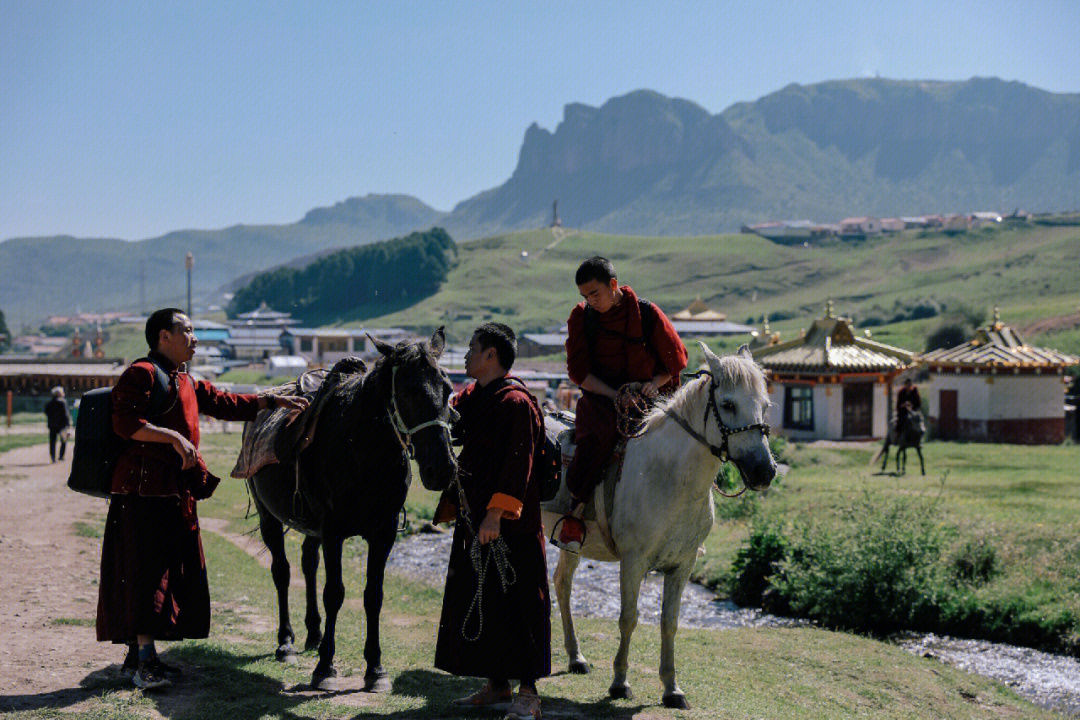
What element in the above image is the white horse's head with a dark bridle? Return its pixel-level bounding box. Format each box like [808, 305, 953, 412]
[700, 342, 777, 490]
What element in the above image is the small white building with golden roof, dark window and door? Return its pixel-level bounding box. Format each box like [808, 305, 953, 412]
[751, 301, 914, 440]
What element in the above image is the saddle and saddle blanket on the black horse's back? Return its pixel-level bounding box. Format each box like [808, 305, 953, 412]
[230, 357, 367, 479]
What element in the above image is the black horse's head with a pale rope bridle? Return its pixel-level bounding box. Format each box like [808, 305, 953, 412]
[368, 328, 457, 490]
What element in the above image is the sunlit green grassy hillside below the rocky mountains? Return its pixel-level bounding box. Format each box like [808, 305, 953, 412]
[340, 220, 1080, 353]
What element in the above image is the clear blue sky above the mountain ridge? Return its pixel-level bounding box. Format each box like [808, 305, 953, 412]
[0, 0, 1080, 240]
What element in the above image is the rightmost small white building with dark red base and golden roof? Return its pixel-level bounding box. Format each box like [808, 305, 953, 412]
[919, 308, 1080, 445]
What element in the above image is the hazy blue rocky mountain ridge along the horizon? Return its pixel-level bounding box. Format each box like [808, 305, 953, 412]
[0, 78, 1080, 317]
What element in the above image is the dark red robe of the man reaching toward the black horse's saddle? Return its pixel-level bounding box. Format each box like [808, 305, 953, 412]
[97, 354, 258, 642]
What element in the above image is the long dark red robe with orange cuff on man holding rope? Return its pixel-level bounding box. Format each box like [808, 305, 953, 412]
[435, 379, 551, 680]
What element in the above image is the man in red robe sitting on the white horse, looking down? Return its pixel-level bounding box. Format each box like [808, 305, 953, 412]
[552, 257, 687, 553]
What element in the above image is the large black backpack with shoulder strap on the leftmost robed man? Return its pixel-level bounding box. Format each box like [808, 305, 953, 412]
[68, 359, 179, 498]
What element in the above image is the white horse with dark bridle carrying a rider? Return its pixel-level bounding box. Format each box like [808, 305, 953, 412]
[543, 343, 777, 708]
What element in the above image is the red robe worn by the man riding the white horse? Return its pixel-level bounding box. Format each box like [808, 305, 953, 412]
[566, 285, 687, 502]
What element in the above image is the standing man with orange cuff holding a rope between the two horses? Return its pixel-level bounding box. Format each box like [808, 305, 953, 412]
[435, 323, 551, 720]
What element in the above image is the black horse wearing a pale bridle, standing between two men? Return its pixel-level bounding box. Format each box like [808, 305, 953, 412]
[248, 328, 457, 692]
